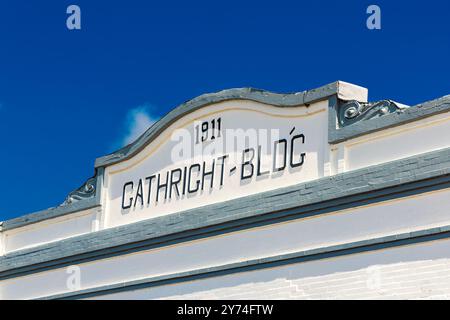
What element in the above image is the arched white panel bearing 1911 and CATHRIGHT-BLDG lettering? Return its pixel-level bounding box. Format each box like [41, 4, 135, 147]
[104, 100, 328, 227]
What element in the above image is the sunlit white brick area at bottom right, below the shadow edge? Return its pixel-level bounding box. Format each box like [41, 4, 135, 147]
[159, 259, 450, 299]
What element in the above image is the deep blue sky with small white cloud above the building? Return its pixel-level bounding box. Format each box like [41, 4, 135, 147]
[0, 0, 450, 220]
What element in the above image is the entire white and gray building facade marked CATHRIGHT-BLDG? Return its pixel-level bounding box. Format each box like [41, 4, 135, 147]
[0, 81, 450, 299]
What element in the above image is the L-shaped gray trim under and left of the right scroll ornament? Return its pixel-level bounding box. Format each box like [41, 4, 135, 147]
[328, 95, 450, 144]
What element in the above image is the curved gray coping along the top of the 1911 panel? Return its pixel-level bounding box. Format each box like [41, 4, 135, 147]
[95, 81, 342, 167]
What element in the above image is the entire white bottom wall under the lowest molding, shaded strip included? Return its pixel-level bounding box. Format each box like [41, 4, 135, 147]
[91, 235, 450, 300]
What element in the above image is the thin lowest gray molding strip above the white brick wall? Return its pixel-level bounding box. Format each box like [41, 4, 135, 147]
[37, 225, 450, 300]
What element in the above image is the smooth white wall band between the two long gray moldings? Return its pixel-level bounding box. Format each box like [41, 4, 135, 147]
[0, 190, 450, 299]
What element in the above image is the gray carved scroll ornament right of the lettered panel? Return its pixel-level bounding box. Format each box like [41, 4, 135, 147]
[338, 100, 408, 127]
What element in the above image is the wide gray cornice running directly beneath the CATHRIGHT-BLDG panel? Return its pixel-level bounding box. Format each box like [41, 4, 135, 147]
[0, 148, 450, 278]
